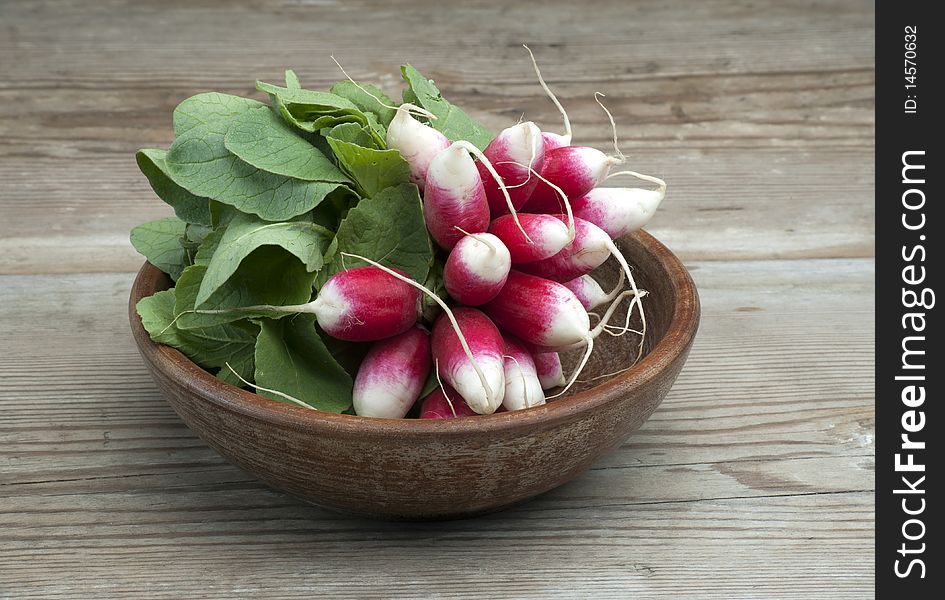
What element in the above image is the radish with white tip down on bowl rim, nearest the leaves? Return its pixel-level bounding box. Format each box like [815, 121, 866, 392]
[353, 326, 431, 419]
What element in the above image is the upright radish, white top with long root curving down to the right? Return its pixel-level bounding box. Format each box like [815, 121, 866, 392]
[423, 141, 517, 250]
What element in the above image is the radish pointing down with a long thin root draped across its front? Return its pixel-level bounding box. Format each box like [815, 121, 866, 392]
[432, 307, 505, 415]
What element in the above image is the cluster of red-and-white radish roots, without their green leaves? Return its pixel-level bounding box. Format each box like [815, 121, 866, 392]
[310, 57, 666, 418]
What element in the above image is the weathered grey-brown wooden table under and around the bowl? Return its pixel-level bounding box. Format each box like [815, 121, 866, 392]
[0, 0, 874, 599]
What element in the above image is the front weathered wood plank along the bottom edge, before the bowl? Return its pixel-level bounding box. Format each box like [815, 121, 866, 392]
[0, 488, 873, 599]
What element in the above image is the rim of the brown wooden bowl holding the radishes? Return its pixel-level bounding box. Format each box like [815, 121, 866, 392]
[129, 230, 700, 436]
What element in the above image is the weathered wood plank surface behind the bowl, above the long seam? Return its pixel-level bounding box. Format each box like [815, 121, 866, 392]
[0, 1, 874, 274]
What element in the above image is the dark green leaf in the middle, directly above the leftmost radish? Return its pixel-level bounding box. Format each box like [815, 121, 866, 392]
[327, 183, 433, 281]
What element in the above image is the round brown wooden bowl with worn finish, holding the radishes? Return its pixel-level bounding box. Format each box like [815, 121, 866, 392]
[129, 232, 699, 519]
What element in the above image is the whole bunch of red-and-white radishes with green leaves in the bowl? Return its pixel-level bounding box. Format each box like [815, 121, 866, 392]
[138, 49, 666, 418]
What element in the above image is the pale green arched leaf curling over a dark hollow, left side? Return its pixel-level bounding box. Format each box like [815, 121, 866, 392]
[194, 215, 332, 308]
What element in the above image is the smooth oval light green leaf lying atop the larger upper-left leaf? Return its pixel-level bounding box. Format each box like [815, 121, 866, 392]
[223, 106, 348, 183]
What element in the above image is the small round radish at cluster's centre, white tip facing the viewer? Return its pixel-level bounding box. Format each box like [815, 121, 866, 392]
[443, 230, 512, 306]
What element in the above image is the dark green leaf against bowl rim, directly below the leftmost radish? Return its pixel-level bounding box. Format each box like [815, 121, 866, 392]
[255, 315, 353, 412]
